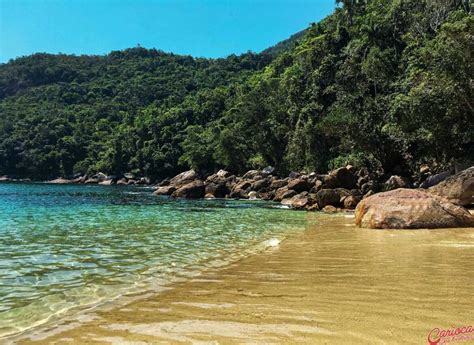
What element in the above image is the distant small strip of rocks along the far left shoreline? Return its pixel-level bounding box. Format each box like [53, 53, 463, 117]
[47, 173, 151, 186]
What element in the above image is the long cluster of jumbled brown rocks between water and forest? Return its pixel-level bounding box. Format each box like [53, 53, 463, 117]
[155, 166, 409, 212]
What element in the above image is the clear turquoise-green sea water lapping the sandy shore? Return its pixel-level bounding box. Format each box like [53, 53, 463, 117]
[0, 183, 304, 337]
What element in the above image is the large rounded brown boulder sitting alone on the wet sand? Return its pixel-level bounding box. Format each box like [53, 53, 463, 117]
[355, 188, 474, 229]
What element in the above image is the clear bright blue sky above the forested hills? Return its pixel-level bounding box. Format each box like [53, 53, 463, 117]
[0, 0, 335, 63]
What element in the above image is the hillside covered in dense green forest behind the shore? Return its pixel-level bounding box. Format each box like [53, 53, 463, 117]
[0, 0, 474, 179]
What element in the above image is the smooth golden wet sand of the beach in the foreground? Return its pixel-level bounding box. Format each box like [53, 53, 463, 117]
[10, 213, 474, 344]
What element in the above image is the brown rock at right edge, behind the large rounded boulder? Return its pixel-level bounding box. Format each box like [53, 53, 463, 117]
[428, 166, 474, 206]
